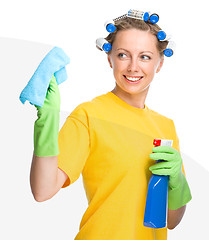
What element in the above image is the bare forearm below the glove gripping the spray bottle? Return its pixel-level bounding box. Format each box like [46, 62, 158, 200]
[167, 205, 186, 230]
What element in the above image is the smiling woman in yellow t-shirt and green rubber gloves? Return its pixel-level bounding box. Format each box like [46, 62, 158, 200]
[31, 10, 191, 240]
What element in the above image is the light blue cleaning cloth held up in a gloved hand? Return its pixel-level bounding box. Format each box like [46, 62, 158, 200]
[19, 47, 70, 107]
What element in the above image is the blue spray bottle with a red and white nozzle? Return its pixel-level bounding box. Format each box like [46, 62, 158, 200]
[143, 139, 173, 228]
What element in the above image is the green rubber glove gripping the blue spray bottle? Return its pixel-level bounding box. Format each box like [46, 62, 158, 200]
[149, 146, 192, 210]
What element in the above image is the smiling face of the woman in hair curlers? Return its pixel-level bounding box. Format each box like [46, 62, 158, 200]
[108, 29, 163, 96]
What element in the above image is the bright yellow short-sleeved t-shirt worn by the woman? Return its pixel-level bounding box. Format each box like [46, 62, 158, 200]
[58, 92, 185, 240]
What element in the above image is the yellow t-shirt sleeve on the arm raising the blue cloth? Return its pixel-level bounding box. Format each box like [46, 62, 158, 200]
[58, 107, 90, 188]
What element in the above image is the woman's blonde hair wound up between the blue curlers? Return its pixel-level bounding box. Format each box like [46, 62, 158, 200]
[105, 17, 168, 56]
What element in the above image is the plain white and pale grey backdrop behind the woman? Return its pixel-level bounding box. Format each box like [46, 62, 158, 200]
[0, 0, 209, 240]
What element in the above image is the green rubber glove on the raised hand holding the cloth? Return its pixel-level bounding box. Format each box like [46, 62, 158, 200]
[34, 75, 60, 157]
